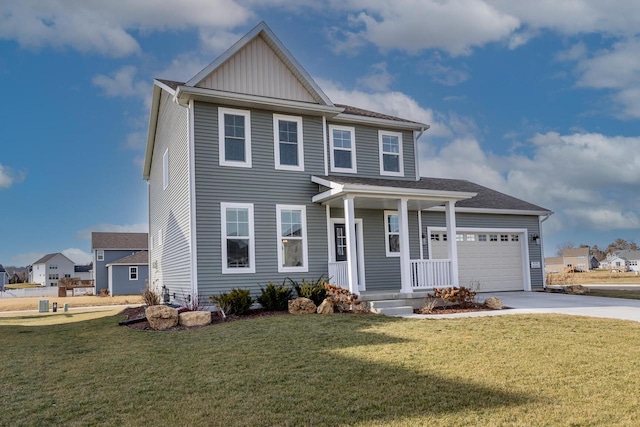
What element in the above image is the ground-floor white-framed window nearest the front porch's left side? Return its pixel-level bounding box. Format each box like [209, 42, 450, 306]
[276, 205, 309, 273]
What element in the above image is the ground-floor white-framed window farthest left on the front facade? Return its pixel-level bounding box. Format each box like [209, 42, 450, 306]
[220, 203, 256, 274]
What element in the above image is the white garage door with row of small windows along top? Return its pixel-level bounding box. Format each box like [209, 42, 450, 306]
[430, 231, 524, 292]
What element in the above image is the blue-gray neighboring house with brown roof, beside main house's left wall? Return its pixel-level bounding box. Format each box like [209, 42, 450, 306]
[91, 232, 149, 295]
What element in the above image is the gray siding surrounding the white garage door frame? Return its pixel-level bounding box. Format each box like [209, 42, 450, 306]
[422, 212, 544, 289]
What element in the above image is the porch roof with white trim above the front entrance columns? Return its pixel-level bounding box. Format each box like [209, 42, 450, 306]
[311, 176, 477, 210]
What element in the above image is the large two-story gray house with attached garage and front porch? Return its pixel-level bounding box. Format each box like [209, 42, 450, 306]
[142, 23, 552, 308]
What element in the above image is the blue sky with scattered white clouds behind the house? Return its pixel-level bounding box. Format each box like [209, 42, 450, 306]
[0, 0, 640, 265]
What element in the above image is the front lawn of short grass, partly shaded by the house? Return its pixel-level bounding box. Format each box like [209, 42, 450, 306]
[0, 315, 640, 426]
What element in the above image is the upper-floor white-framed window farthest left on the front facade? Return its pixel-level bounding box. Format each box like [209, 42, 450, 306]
[218, 108, 251, 168]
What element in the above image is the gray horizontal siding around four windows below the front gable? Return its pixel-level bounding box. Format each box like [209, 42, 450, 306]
[194, 102, 328, 298]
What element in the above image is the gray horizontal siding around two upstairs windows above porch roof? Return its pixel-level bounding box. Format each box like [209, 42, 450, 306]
[327, 122, 416, 181]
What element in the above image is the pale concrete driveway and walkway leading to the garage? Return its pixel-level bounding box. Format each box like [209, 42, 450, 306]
[403, 292, 640, 322]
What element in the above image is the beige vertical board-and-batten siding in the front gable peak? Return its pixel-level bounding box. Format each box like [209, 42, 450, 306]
[197, 37, 317, 103]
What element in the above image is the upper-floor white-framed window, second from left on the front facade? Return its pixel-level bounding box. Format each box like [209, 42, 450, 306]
[273, 114, 304, 171]
